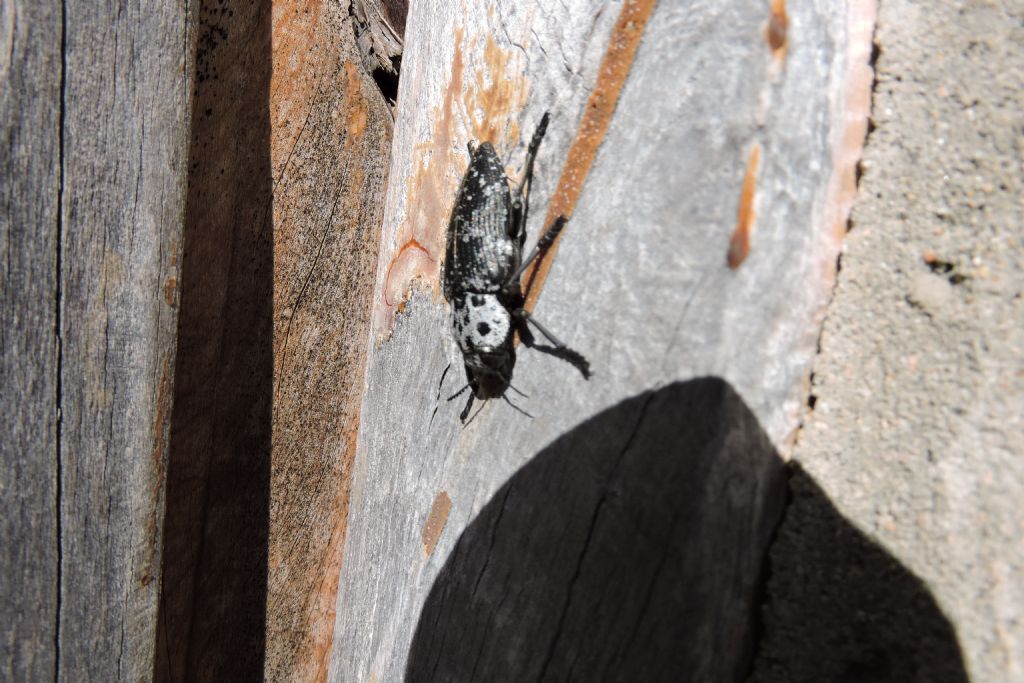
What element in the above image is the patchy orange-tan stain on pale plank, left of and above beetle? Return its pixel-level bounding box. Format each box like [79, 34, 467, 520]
[374, 29, 526, 336]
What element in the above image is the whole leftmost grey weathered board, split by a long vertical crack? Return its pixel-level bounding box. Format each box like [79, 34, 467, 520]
[0, 2, 188, 680]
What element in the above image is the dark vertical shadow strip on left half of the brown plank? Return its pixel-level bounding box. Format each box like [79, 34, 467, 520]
[155, 0, 273, 681]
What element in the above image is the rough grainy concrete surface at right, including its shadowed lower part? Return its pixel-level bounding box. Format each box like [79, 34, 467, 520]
[754, 0, 1024, 681]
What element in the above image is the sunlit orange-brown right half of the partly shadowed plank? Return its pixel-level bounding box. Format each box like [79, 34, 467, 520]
[264, 0, 393, 681]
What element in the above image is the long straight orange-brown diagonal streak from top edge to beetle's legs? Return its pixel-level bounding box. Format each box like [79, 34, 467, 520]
[523, 0, 656, 310]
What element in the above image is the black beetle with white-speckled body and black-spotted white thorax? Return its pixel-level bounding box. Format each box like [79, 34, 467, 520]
[441, 114, 590, 422]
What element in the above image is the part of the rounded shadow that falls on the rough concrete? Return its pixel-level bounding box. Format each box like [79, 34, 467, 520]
[751, 464, 968, 683]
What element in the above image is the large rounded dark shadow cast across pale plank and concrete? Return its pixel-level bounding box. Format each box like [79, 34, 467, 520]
[406, 378, 967, 681]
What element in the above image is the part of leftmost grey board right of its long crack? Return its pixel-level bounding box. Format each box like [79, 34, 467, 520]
[56, 1, 189, 681]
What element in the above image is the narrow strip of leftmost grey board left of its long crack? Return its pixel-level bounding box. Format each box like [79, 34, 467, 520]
[0, 0, 60, 681]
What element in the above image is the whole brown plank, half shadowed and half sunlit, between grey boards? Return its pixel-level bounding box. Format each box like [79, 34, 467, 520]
[157, 0, 392, 681]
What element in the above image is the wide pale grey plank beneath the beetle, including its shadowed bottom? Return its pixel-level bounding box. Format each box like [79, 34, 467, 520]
[330, 0, 870, 681]
